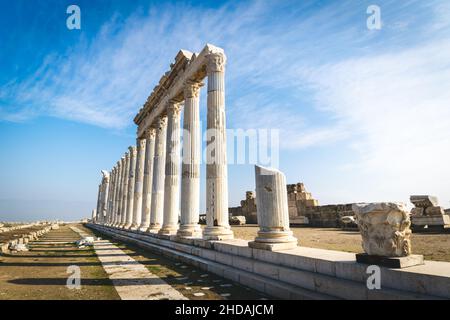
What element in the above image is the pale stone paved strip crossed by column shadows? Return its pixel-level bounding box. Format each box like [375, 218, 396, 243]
[71, 227, 187, 300]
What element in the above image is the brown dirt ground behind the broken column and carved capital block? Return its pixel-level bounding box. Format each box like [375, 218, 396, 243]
[232, 225, 450, 262]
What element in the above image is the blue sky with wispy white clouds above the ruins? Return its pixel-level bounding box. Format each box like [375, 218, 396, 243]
[0, 0, 450, 220]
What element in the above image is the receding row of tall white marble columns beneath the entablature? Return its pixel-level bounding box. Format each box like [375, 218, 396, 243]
[96, 53, 233, 240]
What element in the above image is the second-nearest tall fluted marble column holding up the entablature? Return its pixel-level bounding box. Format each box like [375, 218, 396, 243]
[177, 81, 202, 238]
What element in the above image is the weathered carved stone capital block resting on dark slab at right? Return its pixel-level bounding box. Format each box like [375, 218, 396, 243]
[353, 202, 411, 257]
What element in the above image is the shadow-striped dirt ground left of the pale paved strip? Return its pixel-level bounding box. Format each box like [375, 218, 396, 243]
[0, 226, 119, 300]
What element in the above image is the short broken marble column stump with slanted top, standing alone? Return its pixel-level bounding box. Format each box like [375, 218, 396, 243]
[249, 166, 297, 251]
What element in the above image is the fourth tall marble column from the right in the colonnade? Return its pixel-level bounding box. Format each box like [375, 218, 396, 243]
[149, 116, 167, 232]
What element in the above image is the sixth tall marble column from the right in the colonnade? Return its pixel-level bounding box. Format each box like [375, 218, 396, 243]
[130, 139, 146, 230]
